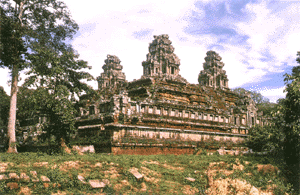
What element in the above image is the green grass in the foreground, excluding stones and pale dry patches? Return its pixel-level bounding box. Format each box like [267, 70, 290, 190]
[0, 153, 290, 194]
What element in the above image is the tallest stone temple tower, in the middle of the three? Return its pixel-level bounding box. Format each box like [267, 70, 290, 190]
[142, 34, 180, 77]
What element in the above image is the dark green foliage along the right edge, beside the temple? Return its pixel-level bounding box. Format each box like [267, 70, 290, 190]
[247, 52, 300, 192]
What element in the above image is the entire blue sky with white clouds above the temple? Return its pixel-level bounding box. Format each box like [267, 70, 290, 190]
[0, 0, 300, 102]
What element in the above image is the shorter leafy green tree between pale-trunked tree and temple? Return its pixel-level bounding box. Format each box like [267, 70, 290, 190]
[24, 59, 94, 151]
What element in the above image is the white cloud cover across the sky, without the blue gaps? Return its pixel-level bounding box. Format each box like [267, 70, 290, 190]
[0, 0, 300, 105]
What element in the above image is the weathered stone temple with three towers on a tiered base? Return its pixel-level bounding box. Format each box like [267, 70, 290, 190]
[77, 35, 264, 153]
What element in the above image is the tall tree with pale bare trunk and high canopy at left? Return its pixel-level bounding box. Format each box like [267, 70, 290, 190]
[0, 0, 87, 153]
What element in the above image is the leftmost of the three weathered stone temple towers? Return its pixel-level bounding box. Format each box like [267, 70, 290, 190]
[97, 55, 126, 89]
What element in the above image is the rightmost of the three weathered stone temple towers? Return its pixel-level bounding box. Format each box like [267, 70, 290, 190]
[198, 51, 228, 89]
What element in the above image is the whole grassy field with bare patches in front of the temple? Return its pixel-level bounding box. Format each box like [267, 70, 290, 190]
[0, 153, 290, 194]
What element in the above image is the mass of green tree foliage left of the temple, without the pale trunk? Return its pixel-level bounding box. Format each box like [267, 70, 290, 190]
[0, 0, 93, 146]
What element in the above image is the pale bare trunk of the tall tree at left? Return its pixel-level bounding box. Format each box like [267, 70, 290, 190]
[7, 65, 18, 153]
